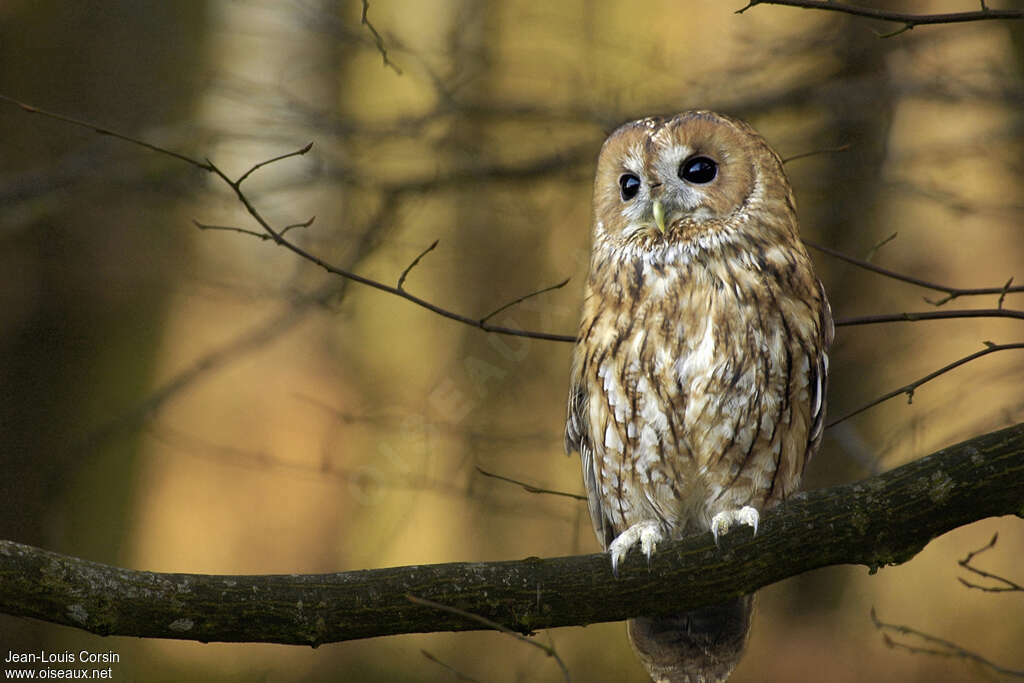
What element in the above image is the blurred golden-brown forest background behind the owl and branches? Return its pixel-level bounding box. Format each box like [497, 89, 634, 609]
[0, 0, 1024, 683]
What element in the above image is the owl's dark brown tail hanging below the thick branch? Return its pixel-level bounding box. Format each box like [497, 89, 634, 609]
[627, 594, 754, 683]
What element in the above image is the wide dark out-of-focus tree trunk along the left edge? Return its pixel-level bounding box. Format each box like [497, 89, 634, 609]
[0, 0, 205, 651]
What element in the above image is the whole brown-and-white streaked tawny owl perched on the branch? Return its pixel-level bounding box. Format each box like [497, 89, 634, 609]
[565, 112, 833, 681]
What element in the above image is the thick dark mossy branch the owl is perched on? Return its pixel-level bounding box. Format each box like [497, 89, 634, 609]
[0, 423, 1024, 645]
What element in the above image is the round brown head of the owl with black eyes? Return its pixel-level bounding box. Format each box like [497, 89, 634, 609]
[594, 112, 797, 253]
